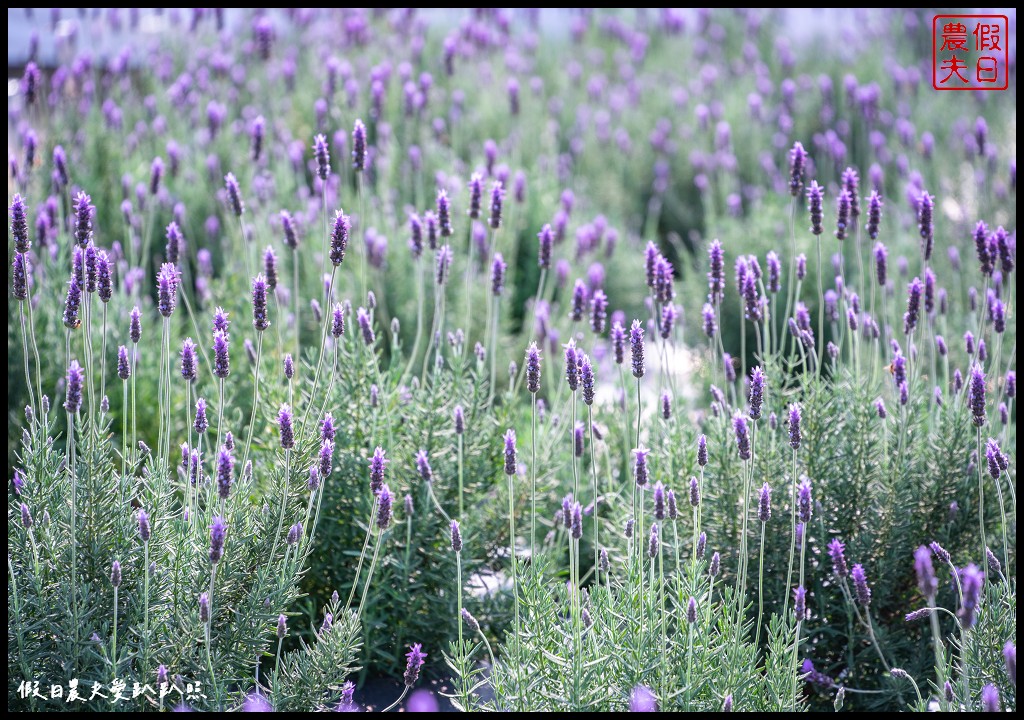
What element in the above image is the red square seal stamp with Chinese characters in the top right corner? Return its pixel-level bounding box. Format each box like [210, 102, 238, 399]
[932, 15, 1010, 90]
